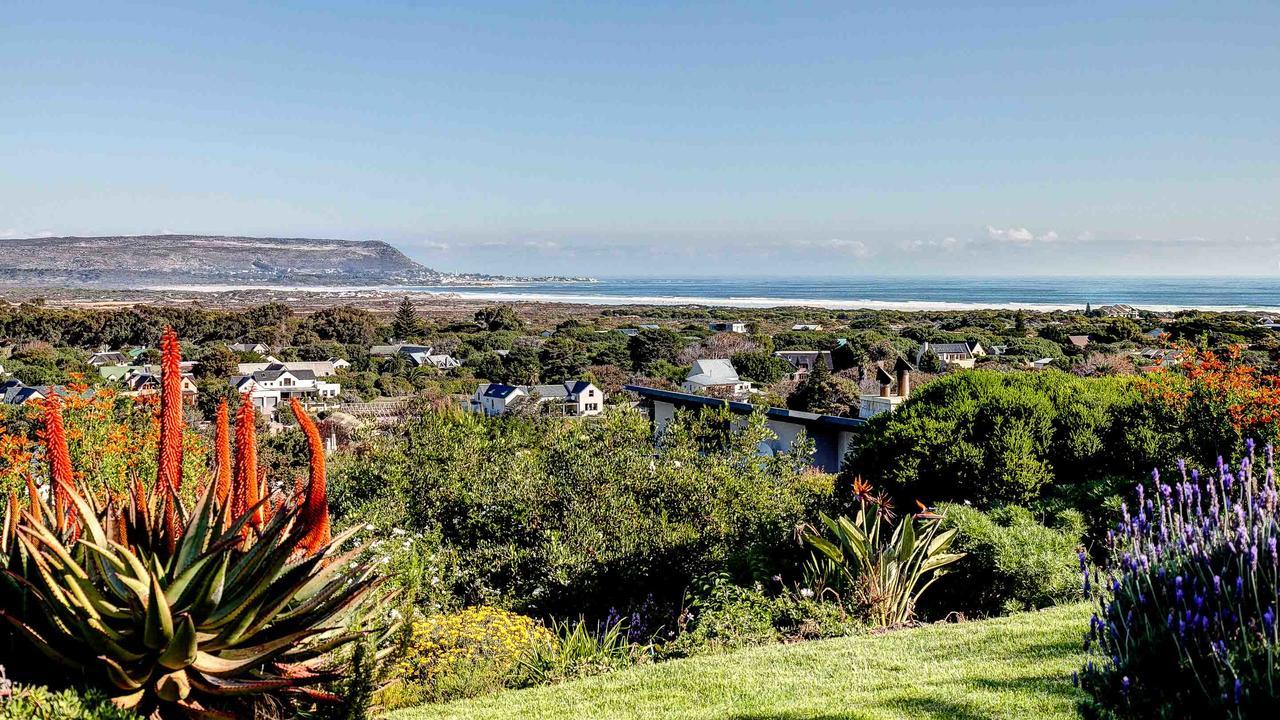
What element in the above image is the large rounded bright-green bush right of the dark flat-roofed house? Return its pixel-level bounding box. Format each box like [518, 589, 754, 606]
[846, 370, 1181, 518]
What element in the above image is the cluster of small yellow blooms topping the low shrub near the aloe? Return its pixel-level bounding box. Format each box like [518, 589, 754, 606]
[399, 599, 550, 685]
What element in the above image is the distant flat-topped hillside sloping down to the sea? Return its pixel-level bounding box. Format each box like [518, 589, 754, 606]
[0, 234, 560, 287]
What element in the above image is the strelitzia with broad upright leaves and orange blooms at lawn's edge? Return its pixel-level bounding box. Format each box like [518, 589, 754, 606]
[801, 488, 965, 628]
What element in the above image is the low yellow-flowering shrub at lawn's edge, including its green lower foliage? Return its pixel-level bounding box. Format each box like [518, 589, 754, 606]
[384, 607, 550, 707]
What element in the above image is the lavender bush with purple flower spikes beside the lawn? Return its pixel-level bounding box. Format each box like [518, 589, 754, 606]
[1076, 441, 1280, 719]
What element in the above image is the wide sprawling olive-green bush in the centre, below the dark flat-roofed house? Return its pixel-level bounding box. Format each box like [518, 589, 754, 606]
[330, 411, 833, 618]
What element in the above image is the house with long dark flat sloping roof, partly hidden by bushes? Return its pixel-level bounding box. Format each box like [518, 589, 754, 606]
[626, 386, 867, 473]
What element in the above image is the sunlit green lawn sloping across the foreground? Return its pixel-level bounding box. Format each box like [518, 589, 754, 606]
[388, 605, 1088, 720]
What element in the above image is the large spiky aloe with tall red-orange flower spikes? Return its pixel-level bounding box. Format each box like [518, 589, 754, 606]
[0, 329, 379, 719]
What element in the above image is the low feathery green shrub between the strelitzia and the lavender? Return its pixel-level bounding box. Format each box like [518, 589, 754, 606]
[928, 505, 1084, 615]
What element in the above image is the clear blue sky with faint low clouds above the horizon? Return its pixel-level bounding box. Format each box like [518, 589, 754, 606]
[0, 0, 1280, 275]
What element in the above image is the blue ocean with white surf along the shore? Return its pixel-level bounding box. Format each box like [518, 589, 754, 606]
[394, 277, 1280, 311]
